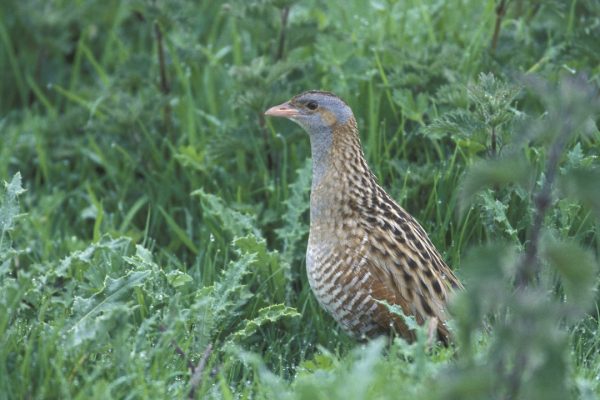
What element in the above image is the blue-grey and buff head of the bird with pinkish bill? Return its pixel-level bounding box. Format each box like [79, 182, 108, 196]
[265, 90, 354, 136]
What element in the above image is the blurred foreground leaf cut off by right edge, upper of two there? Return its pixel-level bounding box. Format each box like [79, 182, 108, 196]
[558, 168, 600, 218]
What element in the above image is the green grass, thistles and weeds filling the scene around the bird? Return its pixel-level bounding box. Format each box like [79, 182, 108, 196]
[0, 0, 600, 399]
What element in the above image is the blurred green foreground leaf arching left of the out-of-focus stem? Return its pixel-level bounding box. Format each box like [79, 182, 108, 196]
[459, 157, 532, 213]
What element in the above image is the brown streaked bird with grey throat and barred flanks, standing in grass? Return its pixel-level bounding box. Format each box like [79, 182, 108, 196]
[265, 90, 463, 344]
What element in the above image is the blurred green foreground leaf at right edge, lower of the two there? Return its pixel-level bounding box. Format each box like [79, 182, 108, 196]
[543, 237, 598, 312]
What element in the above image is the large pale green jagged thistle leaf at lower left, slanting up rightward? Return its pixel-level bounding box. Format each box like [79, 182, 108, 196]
[67, 271, 151, 347]
